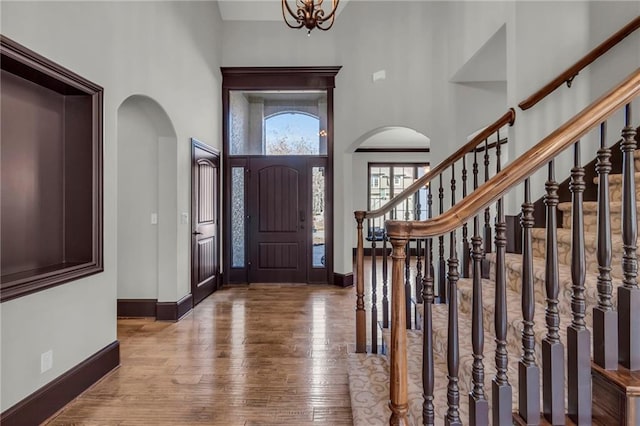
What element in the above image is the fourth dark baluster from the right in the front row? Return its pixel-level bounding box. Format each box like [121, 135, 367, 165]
[542, 160, 565, 425]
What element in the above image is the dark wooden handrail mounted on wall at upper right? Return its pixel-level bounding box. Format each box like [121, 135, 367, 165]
[518, 16, 640, 110]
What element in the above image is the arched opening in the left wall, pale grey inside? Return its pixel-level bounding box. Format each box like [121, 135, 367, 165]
[118, 95, 177, 299]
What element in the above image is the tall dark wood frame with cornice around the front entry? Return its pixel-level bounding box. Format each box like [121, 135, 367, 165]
[221, 66, 342, 283]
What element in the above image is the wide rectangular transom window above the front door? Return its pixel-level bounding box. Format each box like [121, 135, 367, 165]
[229, 90, 327, 156]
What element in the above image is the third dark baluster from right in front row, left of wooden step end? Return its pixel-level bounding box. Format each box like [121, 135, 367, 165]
[567, 141, 591, 424]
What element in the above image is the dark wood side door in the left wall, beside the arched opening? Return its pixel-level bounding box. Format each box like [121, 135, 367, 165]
[191, 142, 220, 305]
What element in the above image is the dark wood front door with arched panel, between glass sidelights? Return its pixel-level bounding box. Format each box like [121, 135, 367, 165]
[247, 157, 310, 283]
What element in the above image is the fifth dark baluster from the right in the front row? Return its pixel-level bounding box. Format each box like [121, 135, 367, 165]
[518, 179, 540, 425]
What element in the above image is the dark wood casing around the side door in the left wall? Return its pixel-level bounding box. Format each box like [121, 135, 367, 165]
[189, 138, 222, 306]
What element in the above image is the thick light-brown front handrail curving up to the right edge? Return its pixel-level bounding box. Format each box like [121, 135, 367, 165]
[385, 68, 640, 239]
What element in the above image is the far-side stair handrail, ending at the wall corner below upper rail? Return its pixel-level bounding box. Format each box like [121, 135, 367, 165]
[355, 108, 516, 219]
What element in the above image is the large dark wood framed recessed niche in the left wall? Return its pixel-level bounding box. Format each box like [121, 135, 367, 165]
[0, 35, 103, 302]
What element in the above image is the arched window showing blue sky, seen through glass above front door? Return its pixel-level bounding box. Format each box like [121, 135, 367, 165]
[264, 111, 322, 155]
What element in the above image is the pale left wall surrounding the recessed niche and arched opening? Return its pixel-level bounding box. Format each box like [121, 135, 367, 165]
[0, 1, 222, 411]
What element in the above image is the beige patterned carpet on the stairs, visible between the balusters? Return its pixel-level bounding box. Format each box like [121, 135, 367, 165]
[349, 151, 640, 426]
